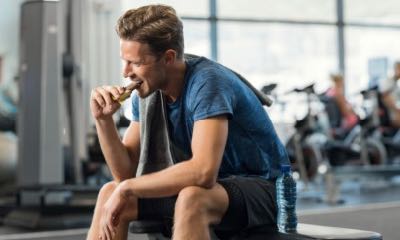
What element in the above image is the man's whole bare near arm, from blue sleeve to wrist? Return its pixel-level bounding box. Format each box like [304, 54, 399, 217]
[119, 116, 228, 198]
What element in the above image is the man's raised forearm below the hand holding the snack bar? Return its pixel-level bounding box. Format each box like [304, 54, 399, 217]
[96, 117, 137, 182]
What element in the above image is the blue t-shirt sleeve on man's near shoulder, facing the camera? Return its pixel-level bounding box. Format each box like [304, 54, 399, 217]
[189, 69, 235, 121]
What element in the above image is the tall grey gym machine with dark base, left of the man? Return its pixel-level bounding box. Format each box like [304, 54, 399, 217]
[4, 1, 99, 229]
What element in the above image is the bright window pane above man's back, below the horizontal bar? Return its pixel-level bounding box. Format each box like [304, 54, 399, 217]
[218, 22, 337, 92]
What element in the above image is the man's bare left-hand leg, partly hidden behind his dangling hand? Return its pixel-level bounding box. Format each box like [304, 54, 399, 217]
[87, 182, 137, 240]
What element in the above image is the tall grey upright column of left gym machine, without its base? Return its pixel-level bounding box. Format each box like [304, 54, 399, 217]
[17, 1, 64, 186]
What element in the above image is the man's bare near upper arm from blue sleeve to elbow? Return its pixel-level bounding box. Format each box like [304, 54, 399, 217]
[192, 115, 228, 185]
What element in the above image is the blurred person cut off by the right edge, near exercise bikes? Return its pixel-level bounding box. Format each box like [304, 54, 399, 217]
[379, 62, 400, 128]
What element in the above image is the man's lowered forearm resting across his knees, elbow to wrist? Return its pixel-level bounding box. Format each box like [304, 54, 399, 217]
[120, 160, 216, 198]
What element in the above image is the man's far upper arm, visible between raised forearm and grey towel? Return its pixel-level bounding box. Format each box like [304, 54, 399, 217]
[122, 121, 140, 172]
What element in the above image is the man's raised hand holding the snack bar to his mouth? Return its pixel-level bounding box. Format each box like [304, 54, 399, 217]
[90, 86, 125, 119]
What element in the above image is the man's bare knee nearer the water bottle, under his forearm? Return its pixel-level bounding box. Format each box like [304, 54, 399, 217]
[175, 186, 207, 217]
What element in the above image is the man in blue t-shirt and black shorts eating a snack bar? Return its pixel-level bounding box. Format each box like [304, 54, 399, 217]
[88, 5, 288, 240]
